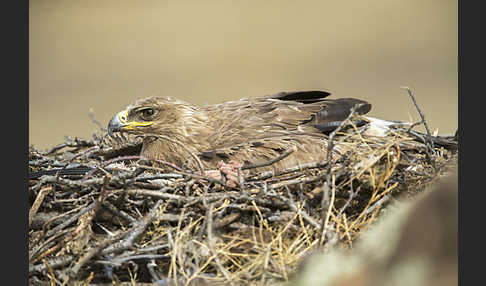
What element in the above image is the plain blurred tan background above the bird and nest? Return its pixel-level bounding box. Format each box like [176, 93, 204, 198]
[29, 0, 458, 149]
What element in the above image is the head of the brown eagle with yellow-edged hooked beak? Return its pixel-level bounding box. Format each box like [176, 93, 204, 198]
[108, 97, 203, 135]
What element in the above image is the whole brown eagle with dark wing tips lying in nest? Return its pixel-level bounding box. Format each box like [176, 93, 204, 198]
[108, 91, 371, 171]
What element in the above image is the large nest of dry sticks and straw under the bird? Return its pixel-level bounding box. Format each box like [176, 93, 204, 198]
[29, 113, 457, 285]
